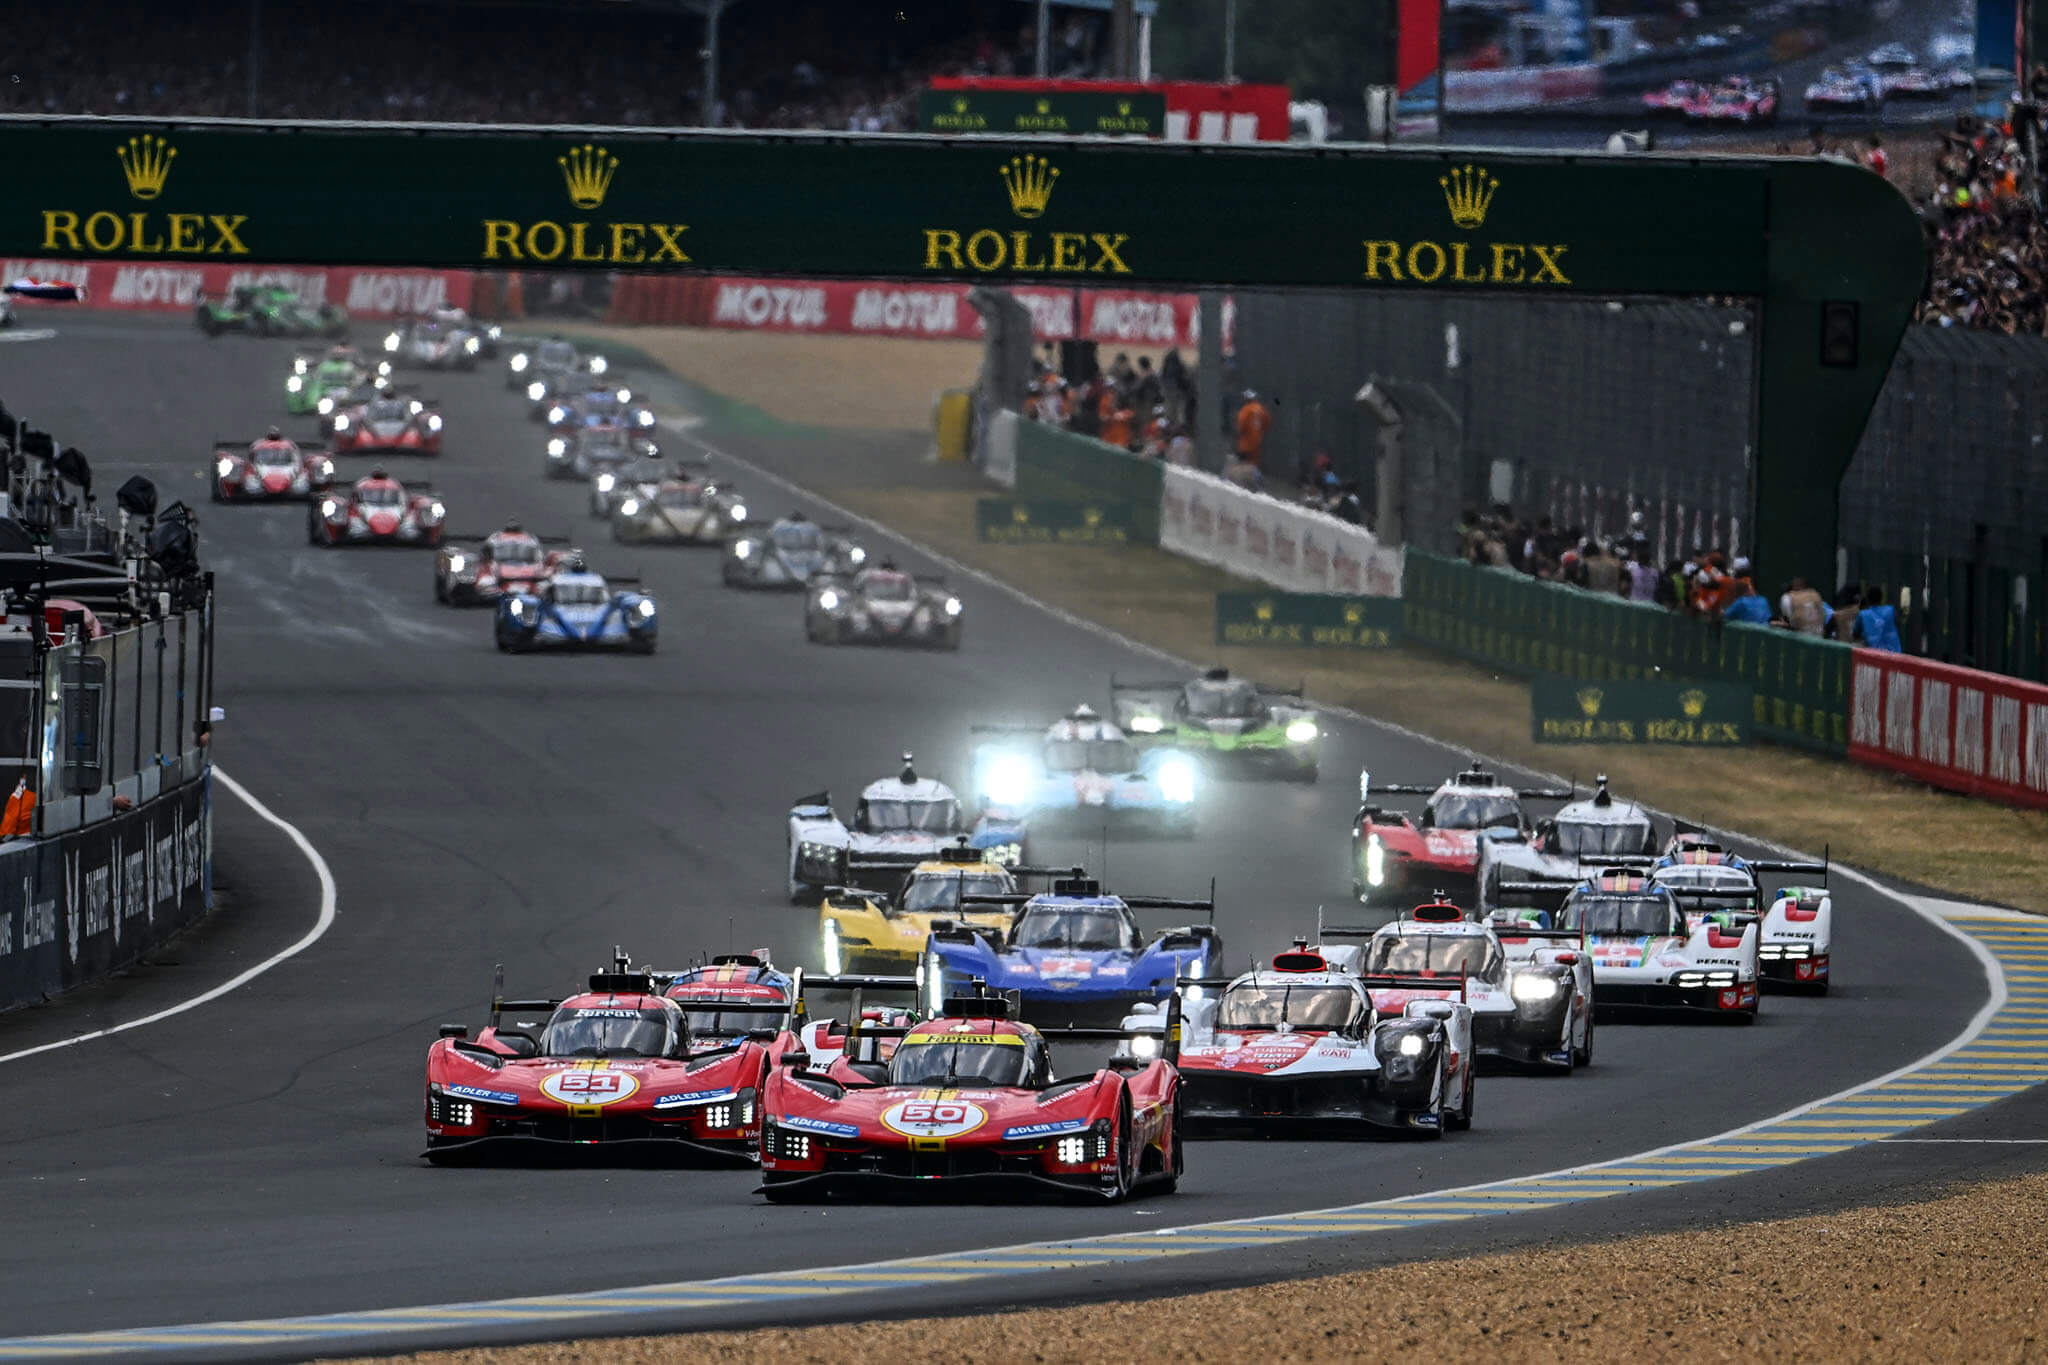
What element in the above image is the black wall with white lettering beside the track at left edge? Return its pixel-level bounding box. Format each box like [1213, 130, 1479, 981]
[0, 776, 213, 1009]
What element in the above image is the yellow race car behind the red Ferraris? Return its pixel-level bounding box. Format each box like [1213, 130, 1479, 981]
[817, 847, 1067, 976]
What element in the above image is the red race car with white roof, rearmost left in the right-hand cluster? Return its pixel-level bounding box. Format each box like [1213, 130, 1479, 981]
[1352, 767, 1573, 902]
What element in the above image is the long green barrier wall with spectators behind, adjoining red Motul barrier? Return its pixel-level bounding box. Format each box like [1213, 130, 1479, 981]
[1401, 546, 1851, 753]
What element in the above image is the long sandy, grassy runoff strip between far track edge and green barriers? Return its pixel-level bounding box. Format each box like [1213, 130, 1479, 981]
[557, 327, 2048, 913]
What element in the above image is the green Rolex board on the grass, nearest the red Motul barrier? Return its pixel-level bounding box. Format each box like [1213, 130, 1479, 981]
[1530, 673, 1751, 749]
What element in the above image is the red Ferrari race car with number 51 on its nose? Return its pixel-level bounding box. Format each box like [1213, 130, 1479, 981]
[426, 962, 782, 1164]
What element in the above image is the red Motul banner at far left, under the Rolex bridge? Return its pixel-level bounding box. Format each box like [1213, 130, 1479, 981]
[0, 260, 473, 317]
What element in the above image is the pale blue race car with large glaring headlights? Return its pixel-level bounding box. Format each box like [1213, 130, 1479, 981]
[975, 706, 1194, 843]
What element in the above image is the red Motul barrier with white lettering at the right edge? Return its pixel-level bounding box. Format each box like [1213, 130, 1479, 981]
[1849, 649, 2048, 806]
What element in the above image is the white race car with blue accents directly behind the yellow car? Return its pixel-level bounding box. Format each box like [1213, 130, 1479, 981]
[788, 753, 1024, 905]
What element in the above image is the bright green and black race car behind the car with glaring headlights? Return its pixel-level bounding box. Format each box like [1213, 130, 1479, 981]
[1110, 669, 1323, 782]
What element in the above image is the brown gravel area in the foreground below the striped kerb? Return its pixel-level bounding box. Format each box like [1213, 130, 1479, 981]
[327, 1175, 2048, 1365]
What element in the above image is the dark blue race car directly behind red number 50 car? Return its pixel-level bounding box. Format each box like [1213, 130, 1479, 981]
[926, 878, 1223, 1023]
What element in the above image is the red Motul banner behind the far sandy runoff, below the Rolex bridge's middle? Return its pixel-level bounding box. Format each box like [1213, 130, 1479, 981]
[610, 274, 1237, 348]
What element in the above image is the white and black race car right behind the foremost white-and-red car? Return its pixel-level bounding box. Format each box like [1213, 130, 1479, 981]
[1323, 900, 1593, 1076]
